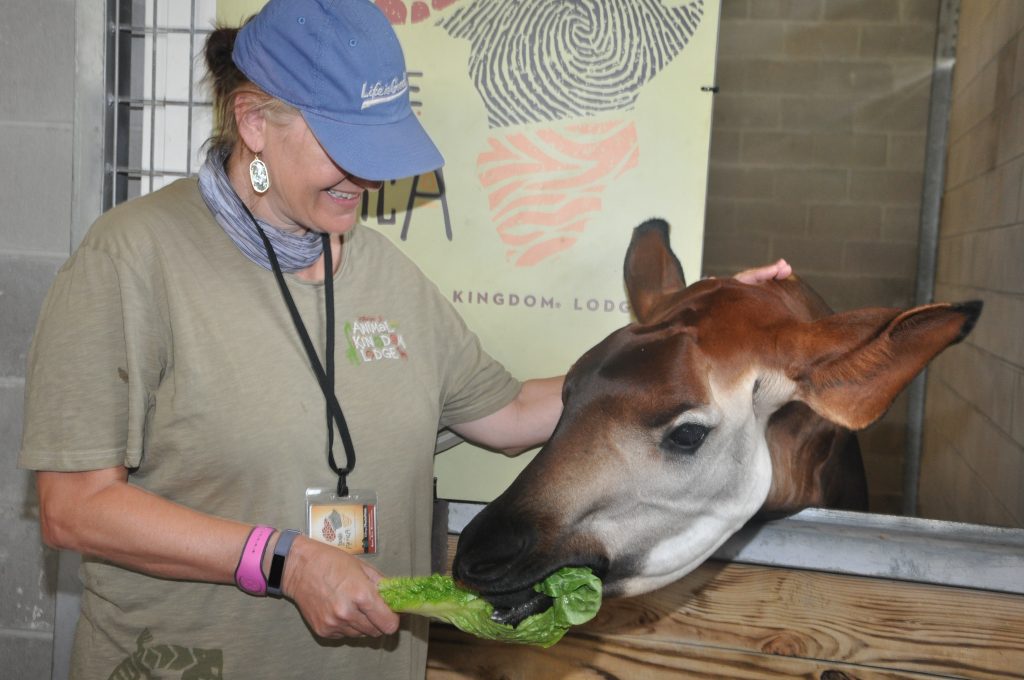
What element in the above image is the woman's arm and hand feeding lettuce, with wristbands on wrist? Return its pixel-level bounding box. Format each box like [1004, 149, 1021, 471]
[36, 467, 398, 637]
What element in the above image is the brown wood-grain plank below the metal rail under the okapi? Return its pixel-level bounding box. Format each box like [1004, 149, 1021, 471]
[428, 544, 1024, 680]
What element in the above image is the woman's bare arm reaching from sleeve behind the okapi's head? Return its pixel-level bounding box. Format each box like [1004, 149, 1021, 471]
[452, 376, 565, 454]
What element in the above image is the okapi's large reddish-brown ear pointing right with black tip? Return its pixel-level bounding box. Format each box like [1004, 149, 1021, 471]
[779, 300, 982, 430]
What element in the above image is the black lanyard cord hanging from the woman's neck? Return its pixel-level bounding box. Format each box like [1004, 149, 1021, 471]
[242, 203, 355, 497]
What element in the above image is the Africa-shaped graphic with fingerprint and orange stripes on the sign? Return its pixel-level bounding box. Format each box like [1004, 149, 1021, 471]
[376, 0, 705, 266]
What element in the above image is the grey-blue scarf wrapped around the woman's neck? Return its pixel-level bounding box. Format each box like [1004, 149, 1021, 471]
[199, 147, 324, 271]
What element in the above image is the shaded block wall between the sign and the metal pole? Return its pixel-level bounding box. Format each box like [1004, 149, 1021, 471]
[703, 0, 938, 512]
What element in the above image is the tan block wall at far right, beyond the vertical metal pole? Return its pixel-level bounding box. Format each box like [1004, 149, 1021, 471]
[920, 0, 1024, 526]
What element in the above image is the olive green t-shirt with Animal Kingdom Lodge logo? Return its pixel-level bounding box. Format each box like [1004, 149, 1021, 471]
[19, 179, 519, 680]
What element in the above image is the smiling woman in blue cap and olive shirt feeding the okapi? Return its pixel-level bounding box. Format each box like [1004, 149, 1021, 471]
[20, 0, 787, 678]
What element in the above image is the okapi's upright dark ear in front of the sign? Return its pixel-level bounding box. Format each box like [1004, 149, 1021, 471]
[624, 219, 686, 324]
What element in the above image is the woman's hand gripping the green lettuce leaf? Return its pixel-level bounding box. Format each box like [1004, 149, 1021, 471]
[282, 536, 398, 638]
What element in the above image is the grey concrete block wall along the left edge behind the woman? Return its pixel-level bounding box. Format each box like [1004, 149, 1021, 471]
[0, 0, 75, 678]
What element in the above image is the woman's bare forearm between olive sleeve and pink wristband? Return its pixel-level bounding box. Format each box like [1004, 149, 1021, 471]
[37, 469, 251, 583]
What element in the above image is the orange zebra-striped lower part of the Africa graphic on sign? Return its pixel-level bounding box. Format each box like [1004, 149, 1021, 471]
[476, 121, 639, 266]
